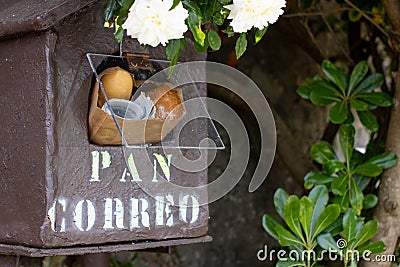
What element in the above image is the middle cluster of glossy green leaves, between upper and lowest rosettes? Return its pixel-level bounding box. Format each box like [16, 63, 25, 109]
[304, 122, 397, 214]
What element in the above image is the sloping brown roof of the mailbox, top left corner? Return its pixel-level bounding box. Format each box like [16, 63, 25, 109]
[0, 0, 96, 38]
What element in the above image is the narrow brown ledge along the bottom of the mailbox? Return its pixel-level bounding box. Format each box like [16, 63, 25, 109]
[0, 236, 212, 258]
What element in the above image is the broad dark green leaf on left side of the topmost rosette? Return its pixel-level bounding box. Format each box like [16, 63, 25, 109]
[309, 80, 342, 106]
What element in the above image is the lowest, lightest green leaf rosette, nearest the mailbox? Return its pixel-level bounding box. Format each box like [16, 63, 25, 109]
[262, 185, 340, 266]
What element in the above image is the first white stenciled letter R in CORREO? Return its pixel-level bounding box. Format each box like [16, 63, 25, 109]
[103, 198, 124, 229]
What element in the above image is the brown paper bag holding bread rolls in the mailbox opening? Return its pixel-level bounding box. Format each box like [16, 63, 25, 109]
[89, 68, 186, 145]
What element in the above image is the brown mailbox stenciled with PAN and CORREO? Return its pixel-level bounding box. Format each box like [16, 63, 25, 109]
[0, 0, 211, 257]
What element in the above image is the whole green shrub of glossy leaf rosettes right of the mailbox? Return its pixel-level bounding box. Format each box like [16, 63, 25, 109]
[262, 60, 398, 266]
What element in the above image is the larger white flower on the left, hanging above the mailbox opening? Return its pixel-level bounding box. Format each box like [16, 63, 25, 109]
[122, 0, 189, 47]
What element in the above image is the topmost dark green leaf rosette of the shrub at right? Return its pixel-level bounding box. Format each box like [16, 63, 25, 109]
[297, 60, 393, 132]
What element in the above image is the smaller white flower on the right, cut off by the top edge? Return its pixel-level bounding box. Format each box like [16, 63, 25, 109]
[225, 0, 286, 33]
